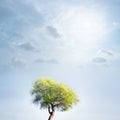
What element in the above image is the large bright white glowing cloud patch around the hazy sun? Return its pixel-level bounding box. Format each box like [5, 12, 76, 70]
[53, 6, 108, 47]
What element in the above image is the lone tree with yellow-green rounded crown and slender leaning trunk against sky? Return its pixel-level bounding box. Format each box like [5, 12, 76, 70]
[31, 78, 79, 120]
